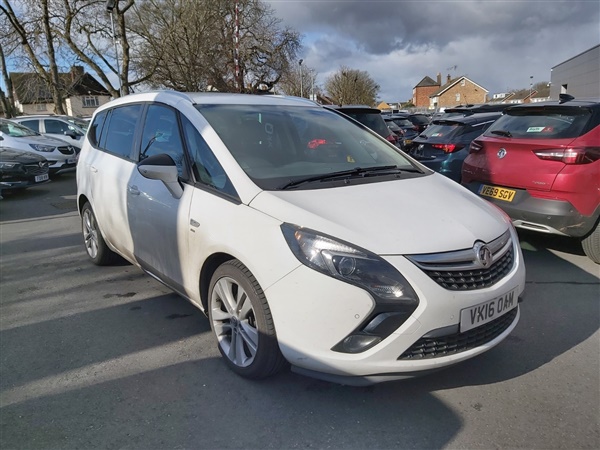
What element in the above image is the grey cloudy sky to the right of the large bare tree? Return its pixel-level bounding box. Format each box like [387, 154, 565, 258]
[267, 0, 600, 102]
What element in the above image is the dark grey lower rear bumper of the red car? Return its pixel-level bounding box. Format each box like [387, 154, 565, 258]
[463, 182, 600, 237]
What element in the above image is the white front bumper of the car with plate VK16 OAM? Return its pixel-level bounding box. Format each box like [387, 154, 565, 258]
[265, 234, 525, 385]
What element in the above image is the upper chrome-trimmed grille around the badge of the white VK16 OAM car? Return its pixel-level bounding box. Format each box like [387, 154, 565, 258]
[407, 230, 514, 291]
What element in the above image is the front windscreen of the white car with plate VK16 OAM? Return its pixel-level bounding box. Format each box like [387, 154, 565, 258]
[197, 105, 422, 190]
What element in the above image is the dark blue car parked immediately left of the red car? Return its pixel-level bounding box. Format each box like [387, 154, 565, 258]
[409, 113, 501, 182]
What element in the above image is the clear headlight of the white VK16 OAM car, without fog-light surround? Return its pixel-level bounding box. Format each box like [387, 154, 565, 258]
[281, 223, 417, 302]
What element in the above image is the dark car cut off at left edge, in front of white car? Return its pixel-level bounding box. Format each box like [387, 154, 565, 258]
[0, 147, 49, 197]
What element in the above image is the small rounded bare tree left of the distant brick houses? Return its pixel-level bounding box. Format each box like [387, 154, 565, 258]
[325, 66, 380, 106]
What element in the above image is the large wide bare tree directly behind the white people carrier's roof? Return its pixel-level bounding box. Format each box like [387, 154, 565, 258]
[132, 0, 300, 92]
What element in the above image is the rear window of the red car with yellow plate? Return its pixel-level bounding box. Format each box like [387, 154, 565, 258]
[485, 107, 592, 139]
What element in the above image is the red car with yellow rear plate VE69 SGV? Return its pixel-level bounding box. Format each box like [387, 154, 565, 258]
[462, 95, 600, 264]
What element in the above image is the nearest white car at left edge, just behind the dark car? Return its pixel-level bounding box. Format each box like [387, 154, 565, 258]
[0, 119, 77, 175]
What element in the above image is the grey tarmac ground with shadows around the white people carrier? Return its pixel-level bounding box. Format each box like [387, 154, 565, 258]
[0, 174, 600, 449]
